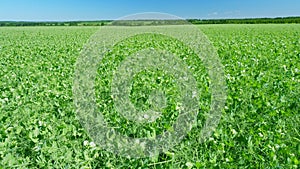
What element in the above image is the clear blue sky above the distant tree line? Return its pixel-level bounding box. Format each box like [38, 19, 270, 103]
[0, 0, 300, 21]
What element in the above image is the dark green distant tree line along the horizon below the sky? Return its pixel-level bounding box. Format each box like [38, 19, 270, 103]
[0, 17, 300, 26]
